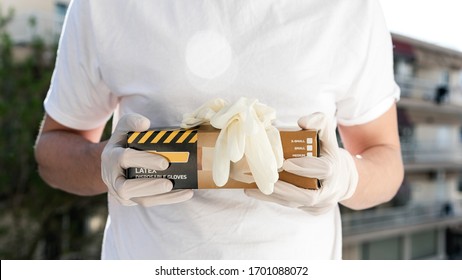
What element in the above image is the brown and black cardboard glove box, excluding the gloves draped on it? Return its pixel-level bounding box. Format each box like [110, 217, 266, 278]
[126, 126, 320, 189]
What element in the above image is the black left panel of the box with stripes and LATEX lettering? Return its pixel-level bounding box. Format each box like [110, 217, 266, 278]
[126, 129, 197, 189]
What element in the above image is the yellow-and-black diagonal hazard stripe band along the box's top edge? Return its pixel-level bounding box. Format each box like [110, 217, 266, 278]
[127, 130, 197, 144]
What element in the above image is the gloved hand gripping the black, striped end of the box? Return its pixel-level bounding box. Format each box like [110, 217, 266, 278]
[101, 114, 193, 207]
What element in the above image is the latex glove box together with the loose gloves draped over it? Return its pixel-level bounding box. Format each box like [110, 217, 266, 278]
[126, 97, 320, 194]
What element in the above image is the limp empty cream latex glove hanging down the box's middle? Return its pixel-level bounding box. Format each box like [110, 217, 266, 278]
[210, 98, 283, 194]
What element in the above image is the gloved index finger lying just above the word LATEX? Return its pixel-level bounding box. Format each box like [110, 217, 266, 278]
[120, 148, 170, 170]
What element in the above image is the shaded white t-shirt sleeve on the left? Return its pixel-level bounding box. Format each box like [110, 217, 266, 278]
[44, 0, 117, 130]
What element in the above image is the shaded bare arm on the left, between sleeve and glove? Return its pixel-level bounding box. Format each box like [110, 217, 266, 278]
[35, 112, 107, 196]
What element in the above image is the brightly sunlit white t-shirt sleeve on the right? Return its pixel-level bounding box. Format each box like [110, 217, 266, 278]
[337, 0, 400, 126]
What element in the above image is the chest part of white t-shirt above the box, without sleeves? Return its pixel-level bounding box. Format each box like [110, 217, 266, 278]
[90, 0, 362, 126]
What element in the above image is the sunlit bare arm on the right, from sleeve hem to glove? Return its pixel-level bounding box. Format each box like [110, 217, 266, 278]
[339, 101, 404, 209]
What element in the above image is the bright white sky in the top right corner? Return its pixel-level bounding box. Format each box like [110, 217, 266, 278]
[379, 0, 462, 52]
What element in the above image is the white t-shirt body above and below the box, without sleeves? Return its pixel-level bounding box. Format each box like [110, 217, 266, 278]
[92, 0, 360, 259]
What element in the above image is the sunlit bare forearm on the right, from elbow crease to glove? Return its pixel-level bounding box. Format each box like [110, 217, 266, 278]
[341, 145, 404, 210]
